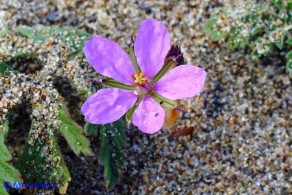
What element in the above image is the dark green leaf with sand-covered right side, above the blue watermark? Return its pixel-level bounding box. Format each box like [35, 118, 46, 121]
[15, 122, 71, 186]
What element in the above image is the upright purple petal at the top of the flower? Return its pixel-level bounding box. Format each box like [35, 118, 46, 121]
[134, 19, 170, 78]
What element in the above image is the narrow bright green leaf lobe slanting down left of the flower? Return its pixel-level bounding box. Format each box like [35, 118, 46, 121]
[59, 105, 93, 156]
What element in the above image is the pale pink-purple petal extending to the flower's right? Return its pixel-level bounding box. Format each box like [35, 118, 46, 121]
[154, 65, 207, 100]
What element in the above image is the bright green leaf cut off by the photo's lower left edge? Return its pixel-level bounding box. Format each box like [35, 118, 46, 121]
[0, 120, 22, 195]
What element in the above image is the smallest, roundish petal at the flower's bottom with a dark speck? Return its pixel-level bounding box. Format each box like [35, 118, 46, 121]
[133, 96, 165, 134]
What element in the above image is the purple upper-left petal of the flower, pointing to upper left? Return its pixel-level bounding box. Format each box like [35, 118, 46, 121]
[83, 35, 135, 85]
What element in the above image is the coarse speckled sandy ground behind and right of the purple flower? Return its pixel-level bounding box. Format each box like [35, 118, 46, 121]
[0, 0, 292, 194]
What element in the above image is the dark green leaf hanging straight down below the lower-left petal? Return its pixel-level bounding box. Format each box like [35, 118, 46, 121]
[98, 120, 127, 188]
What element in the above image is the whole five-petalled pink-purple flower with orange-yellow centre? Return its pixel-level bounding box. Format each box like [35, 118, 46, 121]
[81, 19, 206, 134]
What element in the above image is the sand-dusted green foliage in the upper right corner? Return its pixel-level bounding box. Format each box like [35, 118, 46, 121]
[204, 0, 292, 72]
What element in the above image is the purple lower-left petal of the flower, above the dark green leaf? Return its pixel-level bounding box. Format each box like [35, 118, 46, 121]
[81, 88, 137, 124]
